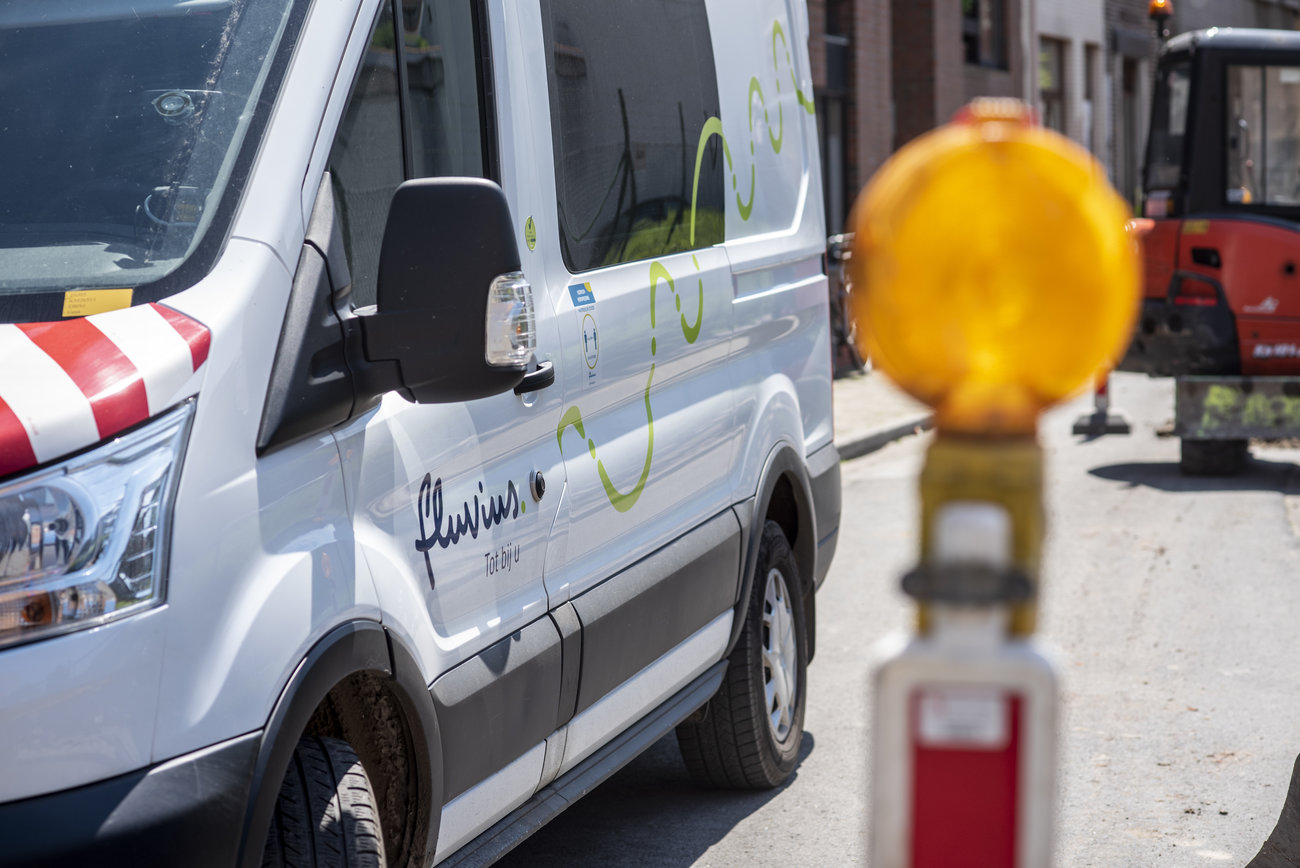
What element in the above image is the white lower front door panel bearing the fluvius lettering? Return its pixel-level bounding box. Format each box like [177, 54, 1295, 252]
[337, 392, 563, 696]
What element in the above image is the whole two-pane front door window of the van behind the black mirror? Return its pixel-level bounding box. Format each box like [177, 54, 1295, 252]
[329, 0, 489, 307]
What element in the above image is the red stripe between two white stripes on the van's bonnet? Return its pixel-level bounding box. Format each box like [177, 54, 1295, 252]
[18, 318, 150, 437]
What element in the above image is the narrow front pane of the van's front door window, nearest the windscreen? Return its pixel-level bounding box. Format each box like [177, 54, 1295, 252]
[329, 3, 404, 307]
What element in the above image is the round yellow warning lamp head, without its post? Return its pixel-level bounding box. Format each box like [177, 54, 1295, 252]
[850, 100, 1140, 434]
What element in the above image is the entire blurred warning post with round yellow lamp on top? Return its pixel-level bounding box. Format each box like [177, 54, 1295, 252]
[868, 100, 1139, 868]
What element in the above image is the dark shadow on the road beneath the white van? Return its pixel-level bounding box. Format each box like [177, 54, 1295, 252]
[497, 732, 815, 868]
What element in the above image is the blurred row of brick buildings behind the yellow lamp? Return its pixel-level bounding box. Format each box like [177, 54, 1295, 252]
[809, 0, 1300, 233]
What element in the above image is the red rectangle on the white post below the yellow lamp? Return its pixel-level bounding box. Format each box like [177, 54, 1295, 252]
[909, 687, 1023, 868]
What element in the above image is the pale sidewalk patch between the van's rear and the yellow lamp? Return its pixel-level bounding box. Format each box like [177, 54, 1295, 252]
[833, 372, 932, 460]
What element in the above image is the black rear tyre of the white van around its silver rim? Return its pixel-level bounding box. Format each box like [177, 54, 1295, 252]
[677, 521, 809, 789]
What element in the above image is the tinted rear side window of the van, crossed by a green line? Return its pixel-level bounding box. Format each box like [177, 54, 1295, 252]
[542, 0, 724, 272]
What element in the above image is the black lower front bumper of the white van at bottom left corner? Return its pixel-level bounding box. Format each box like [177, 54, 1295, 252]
[0, 733, 261, 868]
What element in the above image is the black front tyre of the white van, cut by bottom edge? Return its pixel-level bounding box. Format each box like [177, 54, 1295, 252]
[261, 735, 387, 868]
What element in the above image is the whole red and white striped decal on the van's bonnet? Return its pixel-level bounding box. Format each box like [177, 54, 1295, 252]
[0, 304, 211, 476]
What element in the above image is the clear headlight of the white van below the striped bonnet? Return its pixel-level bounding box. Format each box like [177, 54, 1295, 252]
[0, 402, 194, 647]
